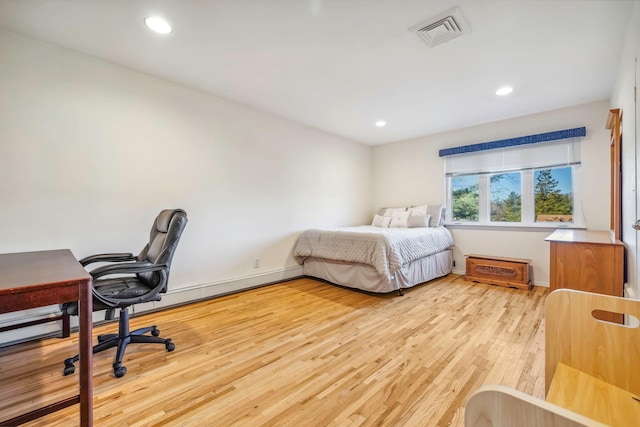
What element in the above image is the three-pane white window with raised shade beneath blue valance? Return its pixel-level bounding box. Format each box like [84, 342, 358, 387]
[441, 128, 584, 227]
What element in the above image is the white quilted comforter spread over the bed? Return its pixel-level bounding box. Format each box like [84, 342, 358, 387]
[294, 225, 453, 279]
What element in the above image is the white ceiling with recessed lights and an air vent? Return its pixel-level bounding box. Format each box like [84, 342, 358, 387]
[0, 0, 634, 145]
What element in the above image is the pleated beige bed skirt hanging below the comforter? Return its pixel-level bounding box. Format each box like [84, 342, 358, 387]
[303, 249, 453, 293]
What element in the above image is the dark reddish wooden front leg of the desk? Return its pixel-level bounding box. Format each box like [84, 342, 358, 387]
[79, 281, 93, 427]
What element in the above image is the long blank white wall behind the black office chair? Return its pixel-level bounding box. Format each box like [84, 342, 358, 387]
[0, 31, 372, 338]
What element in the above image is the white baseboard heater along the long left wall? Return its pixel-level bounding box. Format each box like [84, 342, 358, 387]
[0, 266, 303, 347]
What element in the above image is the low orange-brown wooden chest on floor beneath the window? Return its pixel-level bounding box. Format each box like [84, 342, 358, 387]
[464, 254, 532, 290]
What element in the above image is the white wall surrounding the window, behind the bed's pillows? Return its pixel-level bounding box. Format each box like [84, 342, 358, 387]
[372, 100, 610, 286]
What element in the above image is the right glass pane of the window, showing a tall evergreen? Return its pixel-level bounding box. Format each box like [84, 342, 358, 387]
[535, 167, 573, 222]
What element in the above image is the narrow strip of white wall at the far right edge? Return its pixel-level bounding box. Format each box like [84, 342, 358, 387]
[611, 2, 640, 298]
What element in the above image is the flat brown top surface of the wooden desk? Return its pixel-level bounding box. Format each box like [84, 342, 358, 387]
[0, 249, 91, 295]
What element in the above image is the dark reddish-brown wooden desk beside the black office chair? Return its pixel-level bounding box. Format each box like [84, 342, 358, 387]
[0, 249, 93, 426]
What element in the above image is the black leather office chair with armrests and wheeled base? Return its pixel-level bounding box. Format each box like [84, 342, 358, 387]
[61, 209, 187, 378]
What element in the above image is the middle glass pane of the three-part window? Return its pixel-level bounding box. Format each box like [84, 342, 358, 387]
[489, 172, 522, 222]
